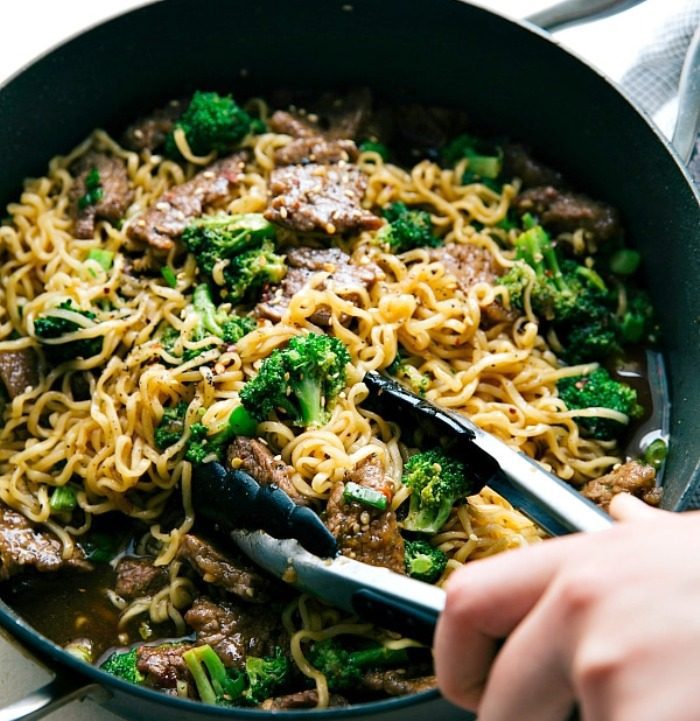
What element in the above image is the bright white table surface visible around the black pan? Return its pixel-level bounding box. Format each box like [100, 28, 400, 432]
[0, 0, 683, 721]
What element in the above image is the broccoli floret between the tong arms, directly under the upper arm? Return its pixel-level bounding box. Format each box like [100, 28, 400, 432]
[402, 449, 470, 533]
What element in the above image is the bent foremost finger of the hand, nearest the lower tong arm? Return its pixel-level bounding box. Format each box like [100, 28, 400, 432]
[434, 536, 577, 710]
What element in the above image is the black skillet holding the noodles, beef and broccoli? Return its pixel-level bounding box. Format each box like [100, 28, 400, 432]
[0, 0, 700, 721]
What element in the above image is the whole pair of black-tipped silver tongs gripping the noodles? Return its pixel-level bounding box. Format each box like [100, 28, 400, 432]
[192, 372, 612, 644]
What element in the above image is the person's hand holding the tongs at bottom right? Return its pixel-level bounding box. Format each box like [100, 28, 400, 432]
[435, 494, 700, 721]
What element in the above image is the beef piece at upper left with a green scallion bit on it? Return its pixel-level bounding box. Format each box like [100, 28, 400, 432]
[70, 151, 134, 238]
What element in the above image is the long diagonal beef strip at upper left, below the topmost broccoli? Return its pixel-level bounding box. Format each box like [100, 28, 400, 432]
[128, 153, 246, 250]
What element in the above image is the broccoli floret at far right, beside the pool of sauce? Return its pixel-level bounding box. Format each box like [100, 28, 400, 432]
[557, 368, 644, 440]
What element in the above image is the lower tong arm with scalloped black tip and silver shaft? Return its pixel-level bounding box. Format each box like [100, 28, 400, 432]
[192, 463, 445, 645]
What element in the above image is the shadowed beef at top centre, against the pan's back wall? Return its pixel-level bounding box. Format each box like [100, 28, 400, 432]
[269, 88, 372, 140]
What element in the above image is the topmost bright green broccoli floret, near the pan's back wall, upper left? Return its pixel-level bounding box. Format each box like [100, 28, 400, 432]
[165, 91, 261, 159]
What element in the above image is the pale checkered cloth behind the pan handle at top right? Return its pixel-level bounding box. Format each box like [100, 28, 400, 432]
[621, 0, 700, 186]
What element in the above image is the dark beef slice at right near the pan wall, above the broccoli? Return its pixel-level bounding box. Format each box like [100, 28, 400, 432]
[513, 185, 622, 243]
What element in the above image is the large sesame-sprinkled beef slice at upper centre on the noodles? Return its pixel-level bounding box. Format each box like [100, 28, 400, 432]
[265, 163, 384, 235]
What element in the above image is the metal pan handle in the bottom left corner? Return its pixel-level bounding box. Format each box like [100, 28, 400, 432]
[0, 670, 109, 721]
